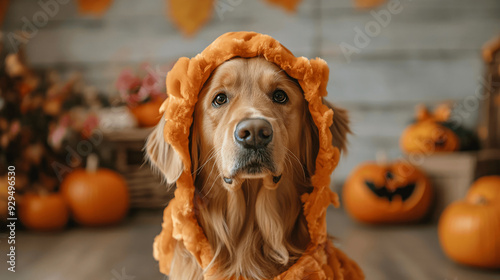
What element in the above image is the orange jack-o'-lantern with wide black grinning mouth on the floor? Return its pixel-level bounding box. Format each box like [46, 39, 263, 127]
[343, 161, 433, 224]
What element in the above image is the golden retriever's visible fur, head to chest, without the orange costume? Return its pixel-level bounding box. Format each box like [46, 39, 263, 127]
[146, 58, 349, 280]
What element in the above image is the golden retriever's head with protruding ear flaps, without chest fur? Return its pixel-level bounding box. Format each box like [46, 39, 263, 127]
[146, 58, 349, 189]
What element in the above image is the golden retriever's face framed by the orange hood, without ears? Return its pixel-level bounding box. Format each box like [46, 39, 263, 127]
[195, 58, 306, 188]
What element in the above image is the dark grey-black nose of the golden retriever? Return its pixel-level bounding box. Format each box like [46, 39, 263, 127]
[234, 119, 273, 149]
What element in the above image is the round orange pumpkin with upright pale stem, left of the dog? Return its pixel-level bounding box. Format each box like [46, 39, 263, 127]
[61, 155, 129, 226]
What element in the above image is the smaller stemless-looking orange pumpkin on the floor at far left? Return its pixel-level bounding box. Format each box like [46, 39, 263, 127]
[18, 193, 69, 231]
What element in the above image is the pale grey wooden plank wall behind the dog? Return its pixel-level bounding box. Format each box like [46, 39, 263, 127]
[2, 0, 500, 188]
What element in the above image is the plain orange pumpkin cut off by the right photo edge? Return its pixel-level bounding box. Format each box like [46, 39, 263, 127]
[438, 176, 500, 268]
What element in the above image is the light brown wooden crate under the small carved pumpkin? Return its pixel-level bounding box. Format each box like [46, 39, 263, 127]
[417, 152, 478, 221]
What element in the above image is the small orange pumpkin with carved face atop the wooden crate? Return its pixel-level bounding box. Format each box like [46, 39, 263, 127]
[400, 120, 460, 155]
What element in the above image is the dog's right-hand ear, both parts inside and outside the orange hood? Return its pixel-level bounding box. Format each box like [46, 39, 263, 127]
[301, 100, 351, 176]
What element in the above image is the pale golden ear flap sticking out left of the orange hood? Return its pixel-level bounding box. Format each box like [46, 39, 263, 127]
[146, 117, 183, 184]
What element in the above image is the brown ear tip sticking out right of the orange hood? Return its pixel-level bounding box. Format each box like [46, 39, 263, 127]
[323, 99, 351, 153]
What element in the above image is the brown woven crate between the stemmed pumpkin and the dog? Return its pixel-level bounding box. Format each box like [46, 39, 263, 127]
[100, 128, 173, 208]
